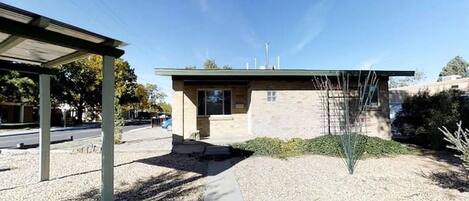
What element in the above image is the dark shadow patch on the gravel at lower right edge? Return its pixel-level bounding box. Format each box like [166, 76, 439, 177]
[421, 171, 469, 192]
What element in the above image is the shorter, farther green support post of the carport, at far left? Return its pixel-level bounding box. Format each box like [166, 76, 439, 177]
[39, 74, 51, 181]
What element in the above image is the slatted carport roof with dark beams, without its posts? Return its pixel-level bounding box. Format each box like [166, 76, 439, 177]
[0, 3, 124, 67]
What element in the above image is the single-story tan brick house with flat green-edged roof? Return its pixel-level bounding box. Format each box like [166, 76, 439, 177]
[156, 68, 414, 143]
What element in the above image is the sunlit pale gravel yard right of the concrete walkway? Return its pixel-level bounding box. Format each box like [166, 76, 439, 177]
[234, 155, 469, 201]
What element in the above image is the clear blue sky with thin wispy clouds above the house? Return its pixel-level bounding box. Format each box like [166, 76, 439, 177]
[0, 0, 469, 101]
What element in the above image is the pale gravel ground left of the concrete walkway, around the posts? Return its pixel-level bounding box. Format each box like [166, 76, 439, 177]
[0, 126, 207, 201]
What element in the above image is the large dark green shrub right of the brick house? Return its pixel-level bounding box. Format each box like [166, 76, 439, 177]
[393, 90, 469, 150]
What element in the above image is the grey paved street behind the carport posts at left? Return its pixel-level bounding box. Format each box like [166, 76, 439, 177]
[0, 124, 149, 149]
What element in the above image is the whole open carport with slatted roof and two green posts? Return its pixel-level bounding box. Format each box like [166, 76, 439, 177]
[0, 3, 124, 200]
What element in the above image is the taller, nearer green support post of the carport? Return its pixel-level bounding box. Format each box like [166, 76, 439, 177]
[101, 56, 115, 201]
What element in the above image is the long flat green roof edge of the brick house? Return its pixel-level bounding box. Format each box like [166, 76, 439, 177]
[155, 68, 415, 77]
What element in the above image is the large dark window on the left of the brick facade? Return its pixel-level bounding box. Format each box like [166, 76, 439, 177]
[197, 90, 231, 116]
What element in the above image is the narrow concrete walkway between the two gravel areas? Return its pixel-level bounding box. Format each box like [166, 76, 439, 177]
[204, 160, 243, 201]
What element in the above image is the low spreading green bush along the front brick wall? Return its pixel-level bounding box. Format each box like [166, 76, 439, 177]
[232, 135, 412, 158]
